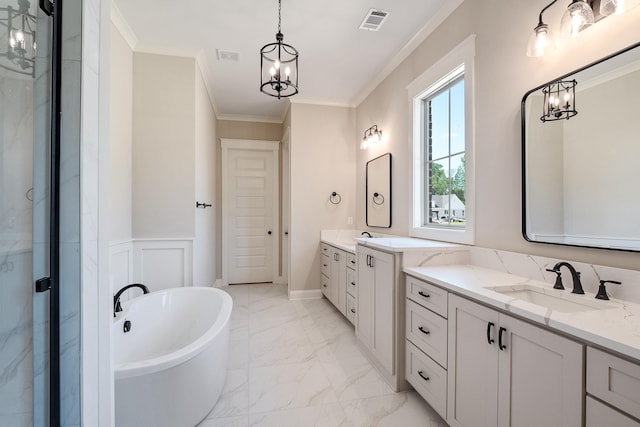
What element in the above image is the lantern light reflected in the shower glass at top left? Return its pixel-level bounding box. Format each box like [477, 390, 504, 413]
[0, 0, 36, 75]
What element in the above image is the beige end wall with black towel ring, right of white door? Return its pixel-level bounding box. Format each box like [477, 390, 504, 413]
[287, 103, 364, 291]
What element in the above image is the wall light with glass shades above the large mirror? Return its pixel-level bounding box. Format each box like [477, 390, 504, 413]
[527, 0, 638, 57]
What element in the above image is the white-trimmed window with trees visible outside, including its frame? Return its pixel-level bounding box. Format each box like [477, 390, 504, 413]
[409, 36, 475, 244]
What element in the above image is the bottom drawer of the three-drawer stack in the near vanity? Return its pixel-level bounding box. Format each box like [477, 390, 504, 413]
[406, 341, 447, 419]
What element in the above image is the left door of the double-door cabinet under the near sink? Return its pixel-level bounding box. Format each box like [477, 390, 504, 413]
[447, 295, 498, 427]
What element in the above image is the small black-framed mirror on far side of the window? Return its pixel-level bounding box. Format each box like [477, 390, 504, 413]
[366, 153, 391, 228]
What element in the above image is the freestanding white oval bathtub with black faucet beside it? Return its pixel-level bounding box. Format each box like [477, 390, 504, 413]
[112, 287, 233, 427]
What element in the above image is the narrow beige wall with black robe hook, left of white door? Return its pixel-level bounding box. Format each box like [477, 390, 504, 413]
[193, 67, 221, 286]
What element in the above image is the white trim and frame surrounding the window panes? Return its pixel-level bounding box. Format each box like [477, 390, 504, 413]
[407, 35, 476, 245]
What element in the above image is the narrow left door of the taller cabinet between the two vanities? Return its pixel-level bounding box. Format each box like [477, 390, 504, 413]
[356, 251, 374, 349]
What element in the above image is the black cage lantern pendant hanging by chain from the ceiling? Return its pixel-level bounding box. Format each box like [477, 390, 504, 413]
[260, 0, 298, 99]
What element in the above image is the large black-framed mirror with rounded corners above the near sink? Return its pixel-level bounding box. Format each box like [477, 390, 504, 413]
[522, 44, 640, 251]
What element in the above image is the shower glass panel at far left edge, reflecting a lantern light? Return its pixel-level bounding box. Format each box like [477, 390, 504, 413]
[0, 0, 38, 427]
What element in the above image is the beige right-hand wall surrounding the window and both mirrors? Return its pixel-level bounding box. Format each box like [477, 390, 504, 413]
[358, 0, 640, 269]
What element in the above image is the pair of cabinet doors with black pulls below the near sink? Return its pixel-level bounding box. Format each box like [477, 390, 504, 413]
[447, 294, 584, 427]
